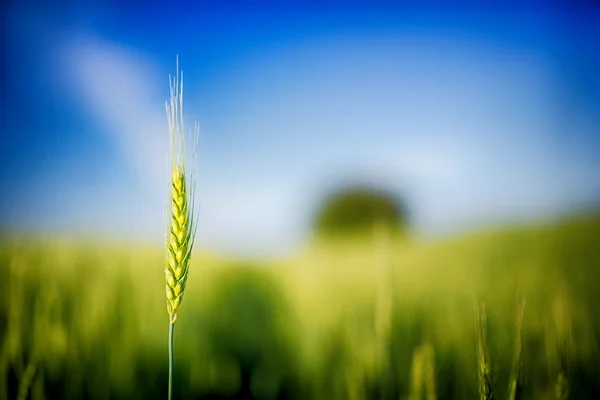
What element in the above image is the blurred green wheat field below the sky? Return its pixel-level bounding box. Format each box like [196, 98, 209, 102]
[0, 215, 600, 399]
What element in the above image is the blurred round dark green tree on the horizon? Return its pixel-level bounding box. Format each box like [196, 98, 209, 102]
[314, 186, 407, 237]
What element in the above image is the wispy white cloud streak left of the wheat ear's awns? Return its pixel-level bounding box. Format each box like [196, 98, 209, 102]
[64, 36, 169, 195]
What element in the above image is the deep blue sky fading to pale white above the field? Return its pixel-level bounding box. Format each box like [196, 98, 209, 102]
[0, 1, 600, 254]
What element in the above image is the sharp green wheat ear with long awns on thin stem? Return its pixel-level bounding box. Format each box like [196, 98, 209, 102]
[165, 58, 198, 400]
